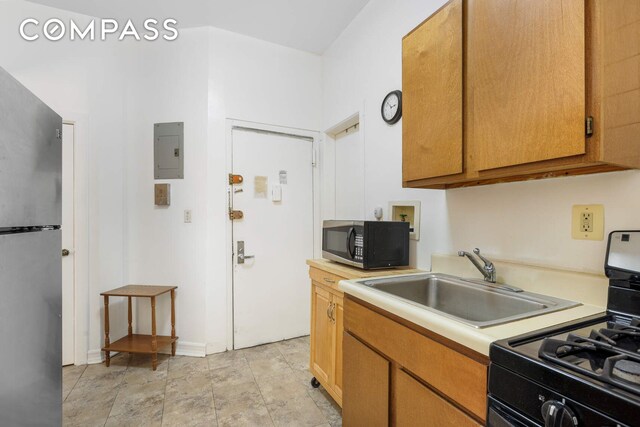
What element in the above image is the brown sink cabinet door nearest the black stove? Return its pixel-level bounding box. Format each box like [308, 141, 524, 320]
[393, 369, 480, 427]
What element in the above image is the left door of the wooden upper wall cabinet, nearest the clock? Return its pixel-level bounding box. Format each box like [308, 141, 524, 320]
[402, 0, 463, 182]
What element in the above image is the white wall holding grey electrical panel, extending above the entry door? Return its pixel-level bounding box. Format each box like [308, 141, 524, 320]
[125, 28, 321, 355]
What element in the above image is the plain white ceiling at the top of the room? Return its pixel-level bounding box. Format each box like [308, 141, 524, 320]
[30, 0, 369, 54]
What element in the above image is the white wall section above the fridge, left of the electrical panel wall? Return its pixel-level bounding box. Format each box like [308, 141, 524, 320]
[0, 1, 132, 362]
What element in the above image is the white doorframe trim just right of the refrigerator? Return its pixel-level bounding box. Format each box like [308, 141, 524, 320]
[62, 111, 90, 365]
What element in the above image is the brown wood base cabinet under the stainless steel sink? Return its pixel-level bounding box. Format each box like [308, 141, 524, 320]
[343, 295, 489, 427]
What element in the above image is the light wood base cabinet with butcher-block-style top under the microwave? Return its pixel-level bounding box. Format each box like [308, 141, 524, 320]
[307, 260, 420, 406]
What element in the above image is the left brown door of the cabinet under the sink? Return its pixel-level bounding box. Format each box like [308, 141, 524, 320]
[342, 332, 390, 427]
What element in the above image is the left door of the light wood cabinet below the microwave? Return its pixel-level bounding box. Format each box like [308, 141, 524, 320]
[311, 284, 334, 386]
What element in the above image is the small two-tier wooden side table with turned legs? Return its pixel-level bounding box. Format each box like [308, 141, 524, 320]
[100, 285, 178, 371]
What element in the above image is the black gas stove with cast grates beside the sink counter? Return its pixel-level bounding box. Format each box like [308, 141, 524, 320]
[487, 231, 640, 427]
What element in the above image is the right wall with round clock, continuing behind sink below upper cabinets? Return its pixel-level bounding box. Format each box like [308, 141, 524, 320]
[323, 0, 640, 273]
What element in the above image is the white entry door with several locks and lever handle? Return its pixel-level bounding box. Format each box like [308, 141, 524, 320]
[232, 128, 313, 348]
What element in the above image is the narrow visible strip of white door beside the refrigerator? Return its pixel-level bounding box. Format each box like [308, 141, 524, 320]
[62, 123, 75, 365]
